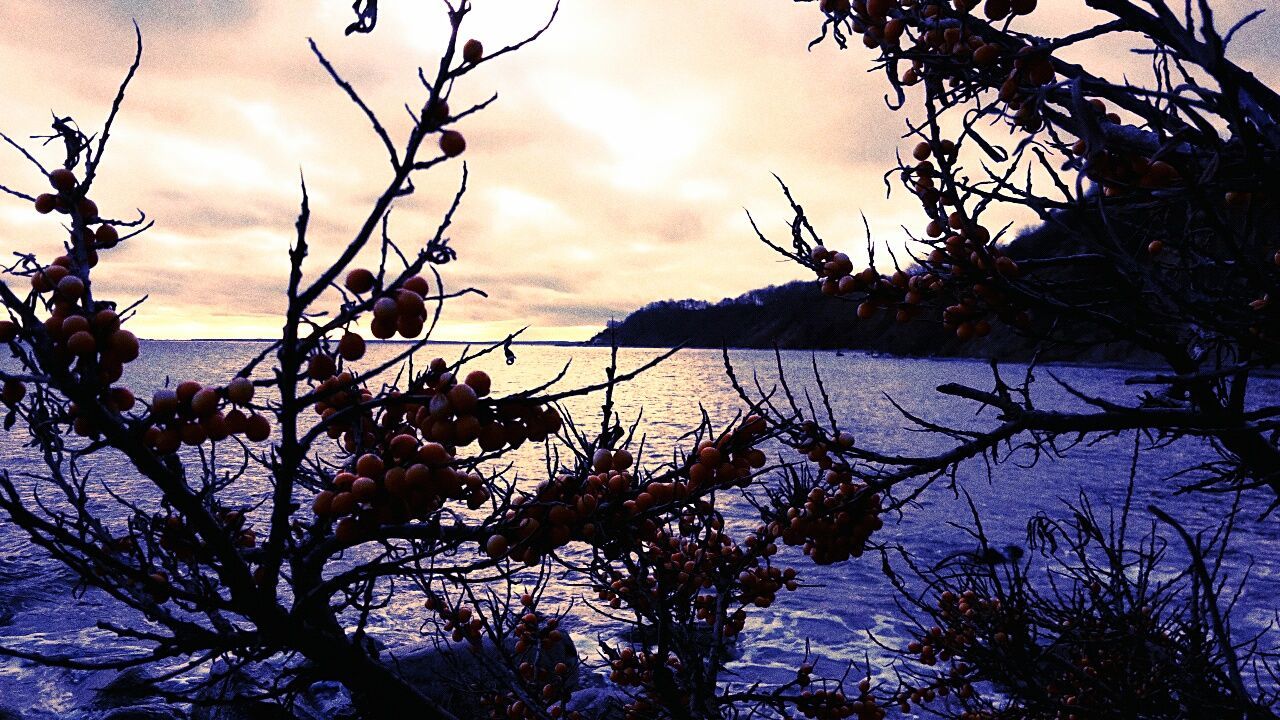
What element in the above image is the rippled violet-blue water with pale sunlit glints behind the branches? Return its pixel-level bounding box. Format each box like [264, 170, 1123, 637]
[0, 342, 1280, 716]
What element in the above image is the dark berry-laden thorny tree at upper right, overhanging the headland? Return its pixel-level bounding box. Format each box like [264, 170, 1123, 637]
[762, 0, 1280, 491]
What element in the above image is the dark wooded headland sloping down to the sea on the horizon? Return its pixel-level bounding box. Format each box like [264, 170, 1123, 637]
[590, 220, 1155, 364]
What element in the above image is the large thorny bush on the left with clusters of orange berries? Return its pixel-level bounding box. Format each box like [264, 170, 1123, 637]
[0, 1, 874, 717]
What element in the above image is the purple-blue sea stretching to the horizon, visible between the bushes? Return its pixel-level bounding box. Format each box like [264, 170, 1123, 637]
[0, 341, 1280, 719]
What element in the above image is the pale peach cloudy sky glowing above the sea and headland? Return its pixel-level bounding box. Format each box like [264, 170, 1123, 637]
[0, 0, 1280, 340]
